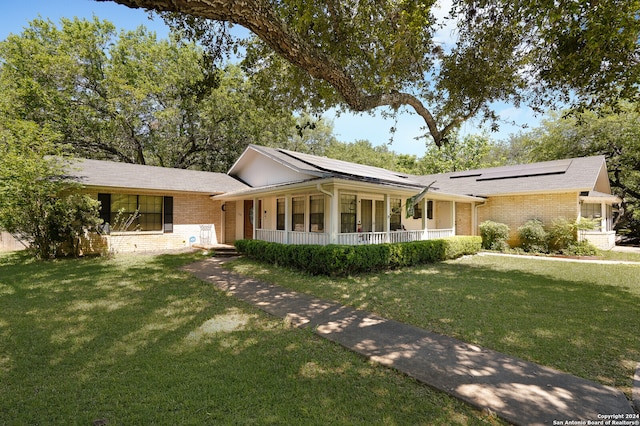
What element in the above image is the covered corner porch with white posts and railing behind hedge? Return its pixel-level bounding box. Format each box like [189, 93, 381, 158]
[216, 179, 484, 245]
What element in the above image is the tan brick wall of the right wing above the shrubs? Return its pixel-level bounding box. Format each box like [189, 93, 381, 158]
[478, 192, 579, 245]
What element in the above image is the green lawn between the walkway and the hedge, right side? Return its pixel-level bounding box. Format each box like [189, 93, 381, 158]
[233, 256, 640, 396]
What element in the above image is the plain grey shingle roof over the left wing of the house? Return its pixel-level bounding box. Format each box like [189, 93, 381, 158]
[69, 159, 247, 194]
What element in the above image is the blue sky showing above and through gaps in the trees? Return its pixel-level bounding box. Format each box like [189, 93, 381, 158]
[0, 0, 540, 157]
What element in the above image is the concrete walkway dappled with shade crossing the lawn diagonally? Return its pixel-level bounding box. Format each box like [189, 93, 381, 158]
[185, 258, 633, 425]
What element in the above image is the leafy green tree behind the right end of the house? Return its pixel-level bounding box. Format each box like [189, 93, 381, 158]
[512, 104, 640, 237]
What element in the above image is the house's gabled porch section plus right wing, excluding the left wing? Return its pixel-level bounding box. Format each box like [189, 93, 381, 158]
[219, 145, 620, 249]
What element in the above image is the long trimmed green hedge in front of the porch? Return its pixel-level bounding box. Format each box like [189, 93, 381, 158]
[235, 237, 481, 276]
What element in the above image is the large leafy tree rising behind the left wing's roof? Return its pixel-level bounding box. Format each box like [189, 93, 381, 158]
[0, 18, 294, 171]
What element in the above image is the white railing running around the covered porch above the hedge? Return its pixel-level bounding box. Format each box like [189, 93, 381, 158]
[256, 229, 454, 246]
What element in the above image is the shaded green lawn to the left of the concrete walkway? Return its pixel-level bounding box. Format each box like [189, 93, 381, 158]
[0, 254, 501, 425]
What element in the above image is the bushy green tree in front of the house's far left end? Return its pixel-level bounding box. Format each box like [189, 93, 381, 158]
[0, 120, 101, 259]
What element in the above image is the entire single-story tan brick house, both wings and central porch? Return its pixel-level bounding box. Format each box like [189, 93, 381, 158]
[0, 145, 620, 255]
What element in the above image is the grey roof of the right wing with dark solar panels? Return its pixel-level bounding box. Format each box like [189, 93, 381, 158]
[413, 155, 611, 197]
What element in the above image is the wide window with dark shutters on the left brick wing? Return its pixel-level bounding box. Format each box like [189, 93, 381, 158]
[98, 194, 173, 232]
